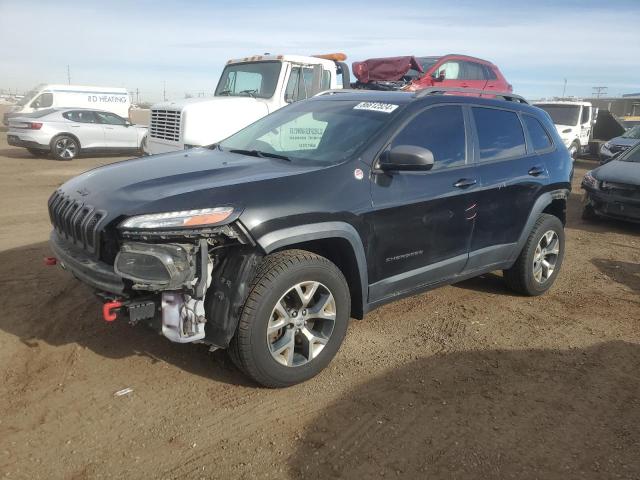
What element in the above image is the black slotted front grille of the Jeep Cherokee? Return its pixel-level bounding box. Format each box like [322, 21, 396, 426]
[49, 192, 106, 256]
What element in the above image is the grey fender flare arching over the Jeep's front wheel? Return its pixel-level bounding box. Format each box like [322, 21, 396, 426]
[256, 222, 369, 313]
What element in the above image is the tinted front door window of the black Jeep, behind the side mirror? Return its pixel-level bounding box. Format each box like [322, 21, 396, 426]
[391, 105, 466, 170]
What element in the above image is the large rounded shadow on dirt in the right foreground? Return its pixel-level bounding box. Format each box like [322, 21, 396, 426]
[289, 342, 640, 479]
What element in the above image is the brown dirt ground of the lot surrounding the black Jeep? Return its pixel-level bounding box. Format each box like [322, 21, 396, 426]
[0, 118, 640, 479]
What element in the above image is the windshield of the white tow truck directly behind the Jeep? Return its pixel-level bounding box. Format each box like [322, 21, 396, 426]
[215, 62, 282, 98]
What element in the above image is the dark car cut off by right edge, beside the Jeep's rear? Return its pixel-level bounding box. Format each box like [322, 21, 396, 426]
[582, 143, 640, 222]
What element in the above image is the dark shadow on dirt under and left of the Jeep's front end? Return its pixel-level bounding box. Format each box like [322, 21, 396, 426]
[0, 242, 249, 385]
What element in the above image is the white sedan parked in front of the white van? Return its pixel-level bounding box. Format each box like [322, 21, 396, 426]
[7, 108, 147, 160]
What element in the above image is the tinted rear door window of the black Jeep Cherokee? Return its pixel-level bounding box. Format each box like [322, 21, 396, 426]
[472, 107, 526, 162]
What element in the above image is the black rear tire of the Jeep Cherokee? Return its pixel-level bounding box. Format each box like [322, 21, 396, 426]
[503, 213, 564, 296]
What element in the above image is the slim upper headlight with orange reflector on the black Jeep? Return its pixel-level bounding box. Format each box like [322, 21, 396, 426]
[120, 207, 233, 230]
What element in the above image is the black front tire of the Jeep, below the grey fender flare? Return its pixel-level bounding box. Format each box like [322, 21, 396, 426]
[229, 250, 351, 388]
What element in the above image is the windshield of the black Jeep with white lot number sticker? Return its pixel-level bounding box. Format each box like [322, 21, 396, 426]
[219, 100, 400, 164]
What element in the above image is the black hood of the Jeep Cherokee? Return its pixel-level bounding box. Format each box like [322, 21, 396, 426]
[60, 148, 327, 221]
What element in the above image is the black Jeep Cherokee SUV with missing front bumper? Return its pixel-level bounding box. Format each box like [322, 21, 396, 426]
[49, 90, 571, 387]
